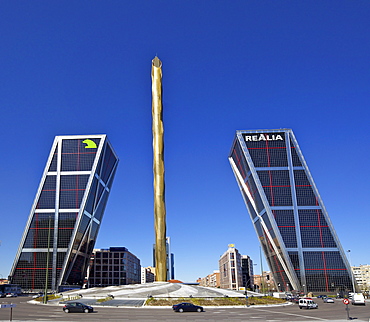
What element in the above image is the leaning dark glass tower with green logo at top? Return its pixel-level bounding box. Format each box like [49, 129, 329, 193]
[10, 135, 118, 291]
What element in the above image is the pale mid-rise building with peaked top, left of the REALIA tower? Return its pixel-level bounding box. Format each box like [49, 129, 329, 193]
[218, 244, 243, 290]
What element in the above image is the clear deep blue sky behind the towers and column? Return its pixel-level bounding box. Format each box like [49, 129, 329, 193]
[0, 0, 370, 281]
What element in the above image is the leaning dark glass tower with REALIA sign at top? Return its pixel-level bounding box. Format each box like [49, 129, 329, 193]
[229, 129, 353, 293]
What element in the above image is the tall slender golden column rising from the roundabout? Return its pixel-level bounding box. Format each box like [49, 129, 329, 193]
[152, 56, 167, 282]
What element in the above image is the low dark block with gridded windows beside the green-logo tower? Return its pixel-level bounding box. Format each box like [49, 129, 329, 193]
[88, 247, 141, 287]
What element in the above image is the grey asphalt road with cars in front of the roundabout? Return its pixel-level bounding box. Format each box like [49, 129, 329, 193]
[0, 296, 370, 322]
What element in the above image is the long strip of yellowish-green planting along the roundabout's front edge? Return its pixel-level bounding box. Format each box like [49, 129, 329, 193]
[145, 296, 286, 306]
